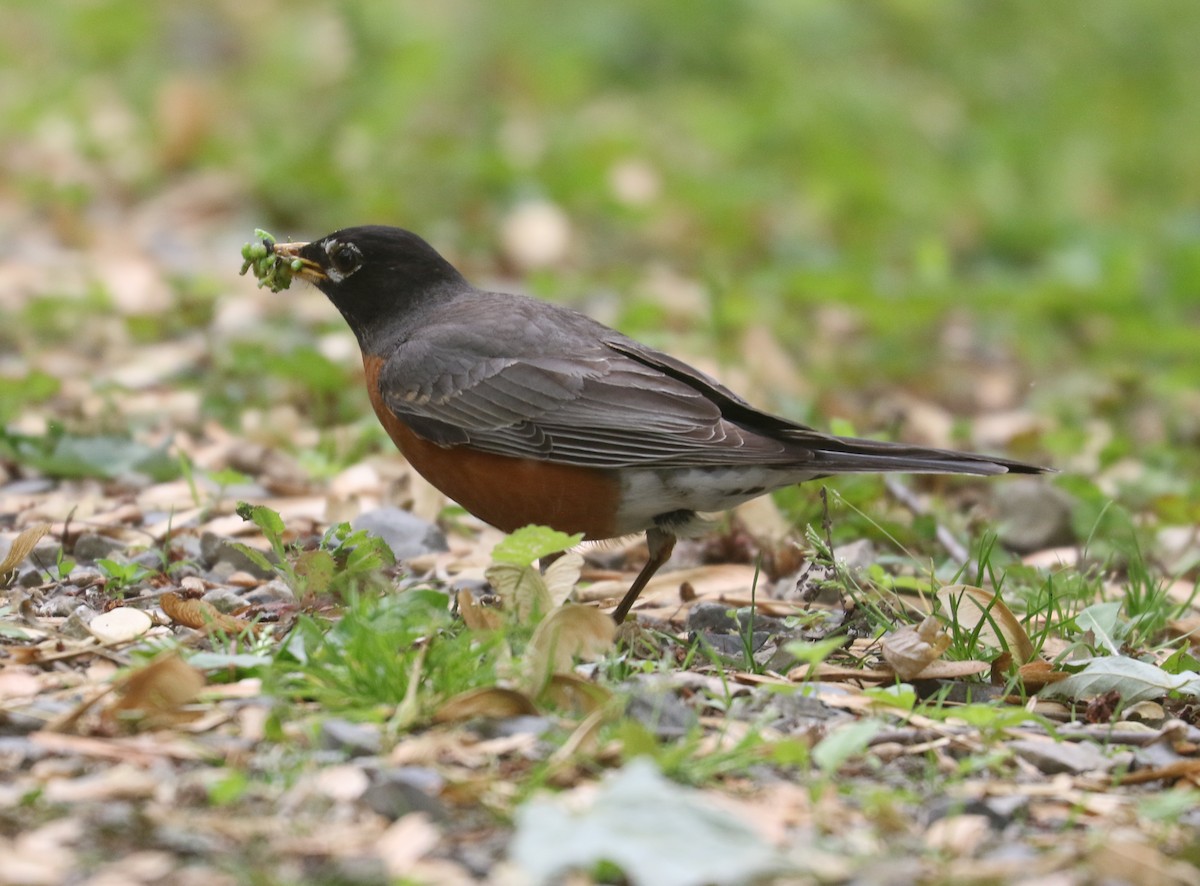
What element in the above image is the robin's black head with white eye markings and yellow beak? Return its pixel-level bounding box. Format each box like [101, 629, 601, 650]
[275, 225, 467, 345]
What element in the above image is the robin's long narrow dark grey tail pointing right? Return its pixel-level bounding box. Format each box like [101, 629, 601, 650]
[805, 436, 1054, 477]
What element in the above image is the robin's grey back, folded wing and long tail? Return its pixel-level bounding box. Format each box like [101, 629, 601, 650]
[379, 295, 1042, 475]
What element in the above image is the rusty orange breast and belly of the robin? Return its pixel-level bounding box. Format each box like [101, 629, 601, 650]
[362, 354, 620, 539]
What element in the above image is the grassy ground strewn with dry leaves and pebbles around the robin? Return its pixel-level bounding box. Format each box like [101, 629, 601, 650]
[0, 2, 1200, 884]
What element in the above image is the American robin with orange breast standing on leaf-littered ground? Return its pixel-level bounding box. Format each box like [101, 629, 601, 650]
[268, 226, 1044, 622]
